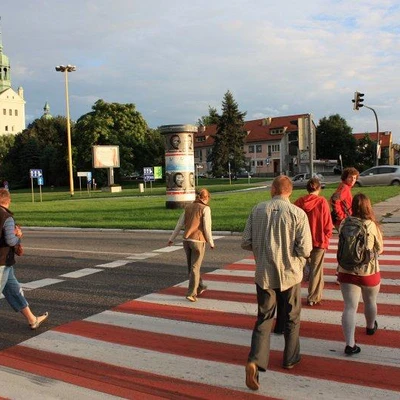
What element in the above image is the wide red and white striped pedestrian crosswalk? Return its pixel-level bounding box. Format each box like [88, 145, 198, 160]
[0, 238, 400, 400]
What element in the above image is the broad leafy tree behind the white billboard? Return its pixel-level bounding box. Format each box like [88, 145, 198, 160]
[73, 100, 164, 183]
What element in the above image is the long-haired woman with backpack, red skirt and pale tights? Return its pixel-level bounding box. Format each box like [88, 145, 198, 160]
[338, 193, 383, 356]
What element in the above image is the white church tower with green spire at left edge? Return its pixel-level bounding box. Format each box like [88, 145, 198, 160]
[0, 20, 25, 135]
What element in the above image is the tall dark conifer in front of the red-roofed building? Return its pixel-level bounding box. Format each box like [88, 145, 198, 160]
[208, 90, 246, 176]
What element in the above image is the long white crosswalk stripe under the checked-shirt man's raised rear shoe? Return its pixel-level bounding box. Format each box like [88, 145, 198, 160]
[21, 331, 396, 400]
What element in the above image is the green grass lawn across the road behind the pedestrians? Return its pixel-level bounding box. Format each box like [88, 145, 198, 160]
[10, 179, 400, 232]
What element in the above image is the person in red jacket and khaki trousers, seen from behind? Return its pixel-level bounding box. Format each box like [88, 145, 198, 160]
[294, 178, 333, 306]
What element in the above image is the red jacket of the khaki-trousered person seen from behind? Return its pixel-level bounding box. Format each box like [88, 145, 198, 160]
[294, 194, 333, 249]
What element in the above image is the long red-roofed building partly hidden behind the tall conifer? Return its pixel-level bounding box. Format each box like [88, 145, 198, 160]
[194, 114, 336, 176]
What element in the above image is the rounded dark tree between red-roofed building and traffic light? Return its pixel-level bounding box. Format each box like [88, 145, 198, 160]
[316, 114, 357, 167]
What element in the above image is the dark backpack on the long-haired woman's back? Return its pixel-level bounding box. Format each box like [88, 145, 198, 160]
[337, 217, 373, 273]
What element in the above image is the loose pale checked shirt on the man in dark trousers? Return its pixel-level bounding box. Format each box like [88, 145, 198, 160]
[242, 196, 312, 291]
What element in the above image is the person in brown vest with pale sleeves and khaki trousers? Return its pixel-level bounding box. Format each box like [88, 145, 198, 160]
[168, 189, 214, 302]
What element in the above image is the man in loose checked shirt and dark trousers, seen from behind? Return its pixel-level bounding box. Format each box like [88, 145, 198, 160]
[242, 175, 312, 390]
